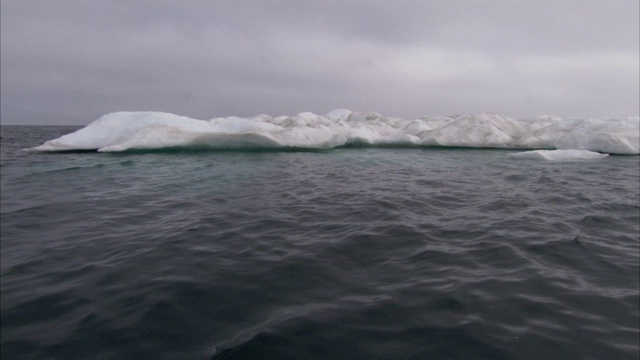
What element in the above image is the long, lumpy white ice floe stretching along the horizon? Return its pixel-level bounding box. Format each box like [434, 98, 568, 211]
[30, 109, 640, 154]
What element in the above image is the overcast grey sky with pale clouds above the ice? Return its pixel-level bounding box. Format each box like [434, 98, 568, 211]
[0, 0, 640, 125]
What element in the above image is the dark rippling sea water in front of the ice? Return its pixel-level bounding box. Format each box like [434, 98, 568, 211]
[0, 126, 640, 359]
